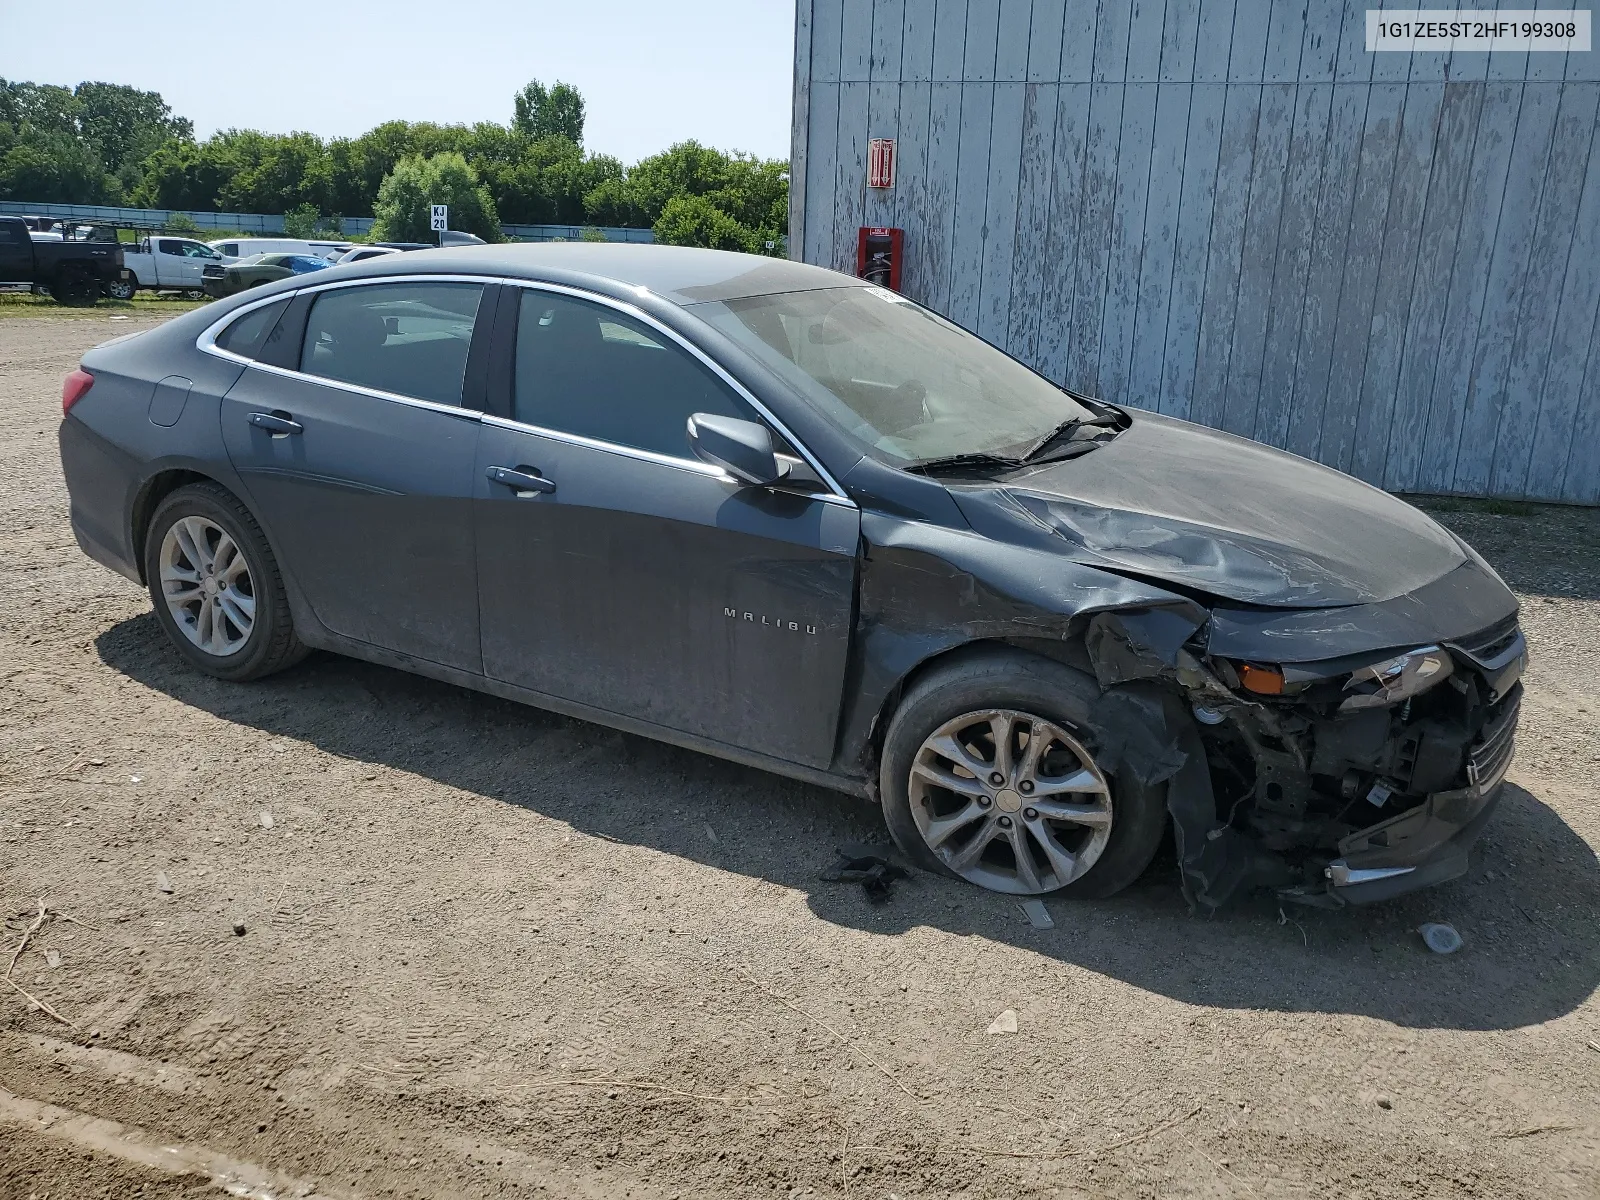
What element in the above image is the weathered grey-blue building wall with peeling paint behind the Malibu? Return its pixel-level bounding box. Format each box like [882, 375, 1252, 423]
[790, 0, 1600, 504]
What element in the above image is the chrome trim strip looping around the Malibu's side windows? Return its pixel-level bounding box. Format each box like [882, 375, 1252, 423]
[195, 274, 858, 509]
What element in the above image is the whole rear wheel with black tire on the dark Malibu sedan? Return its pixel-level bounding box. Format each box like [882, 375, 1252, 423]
[144, 483, 307, 680]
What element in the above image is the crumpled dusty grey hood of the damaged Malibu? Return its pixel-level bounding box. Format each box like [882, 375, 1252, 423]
[952, 410, 1466, 608]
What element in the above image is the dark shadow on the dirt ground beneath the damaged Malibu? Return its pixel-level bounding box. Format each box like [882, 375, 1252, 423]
[96, 614, 1600, 1029]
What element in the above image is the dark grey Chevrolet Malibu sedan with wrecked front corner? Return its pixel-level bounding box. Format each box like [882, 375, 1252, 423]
[61, 251, 1525, 907]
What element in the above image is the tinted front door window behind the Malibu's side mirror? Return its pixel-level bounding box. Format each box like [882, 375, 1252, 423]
[512, 290, 757, 458]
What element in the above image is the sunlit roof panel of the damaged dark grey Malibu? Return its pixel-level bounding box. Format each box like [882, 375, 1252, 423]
[323, 242, 866, 304]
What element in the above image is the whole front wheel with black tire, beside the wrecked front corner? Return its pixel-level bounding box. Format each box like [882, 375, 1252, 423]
[878, 648, 1166, 899]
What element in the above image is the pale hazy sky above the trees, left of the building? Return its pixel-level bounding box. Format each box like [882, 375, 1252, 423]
[0, 0, 795, 163]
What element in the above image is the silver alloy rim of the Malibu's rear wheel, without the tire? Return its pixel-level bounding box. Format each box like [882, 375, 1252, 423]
[160, 517, 256, 658]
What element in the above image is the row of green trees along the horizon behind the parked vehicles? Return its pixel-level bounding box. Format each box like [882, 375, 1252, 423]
[0, 80, 789, 253]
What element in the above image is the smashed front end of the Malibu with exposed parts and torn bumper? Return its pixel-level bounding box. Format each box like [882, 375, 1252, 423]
[1086, 610, 1526, 907]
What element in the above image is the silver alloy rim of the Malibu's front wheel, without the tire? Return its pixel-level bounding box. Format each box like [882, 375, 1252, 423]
[909, 709, 1112, 896]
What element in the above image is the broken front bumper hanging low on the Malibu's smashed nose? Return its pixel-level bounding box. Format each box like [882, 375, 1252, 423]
[1283, 685, 1522, 904]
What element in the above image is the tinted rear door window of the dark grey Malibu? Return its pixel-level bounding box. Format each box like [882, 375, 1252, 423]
[301, 282, 483, 406]
